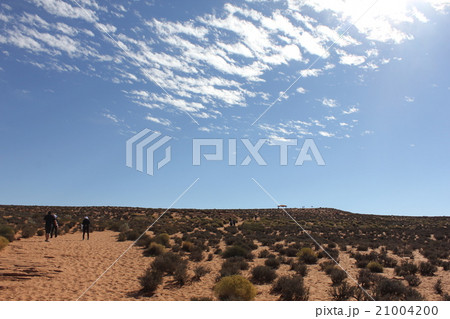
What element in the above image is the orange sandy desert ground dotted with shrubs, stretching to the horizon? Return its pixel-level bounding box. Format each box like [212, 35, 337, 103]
[0, 206, 450, 301]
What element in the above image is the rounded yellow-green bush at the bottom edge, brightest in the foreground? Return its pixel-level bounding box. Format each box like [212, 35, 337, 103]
[214, 275, 256, 301]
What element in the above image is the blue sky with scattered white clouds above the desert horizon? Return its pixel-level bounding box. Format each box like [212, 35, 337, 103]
[0, 0, 450, 215]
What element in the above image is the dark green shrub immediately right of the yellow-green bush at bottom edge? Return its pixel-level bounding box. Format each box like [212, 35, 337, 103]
[271, 275, 309, 301]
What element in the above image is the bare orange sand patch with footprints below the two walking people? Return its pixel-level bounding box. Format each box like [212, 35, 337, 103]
[0, 231, 150, 300]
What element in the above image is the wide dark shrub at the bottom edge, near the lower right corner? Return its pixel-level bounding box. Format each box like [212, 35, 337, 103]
[373, 277, 423, 301]
